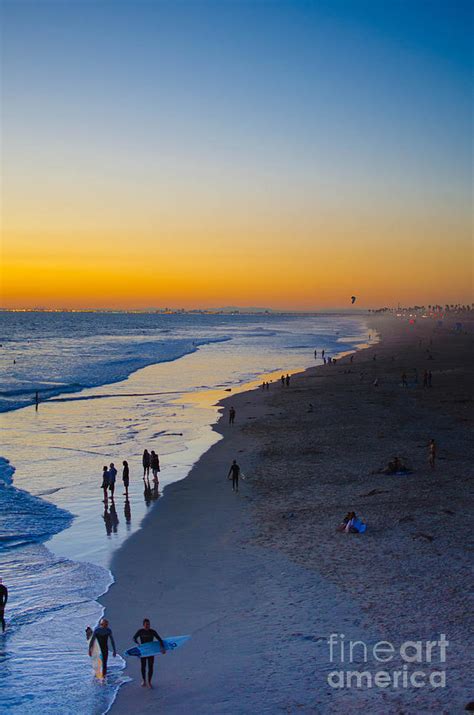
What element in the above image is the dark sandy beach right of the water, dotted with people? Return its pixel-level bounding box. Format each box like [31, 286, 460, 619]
[101, 316, 474, 715]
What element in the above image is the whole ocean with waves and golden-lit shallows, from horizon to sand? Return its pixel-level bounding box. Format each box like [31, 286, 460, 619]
[0, 313, 368, 715]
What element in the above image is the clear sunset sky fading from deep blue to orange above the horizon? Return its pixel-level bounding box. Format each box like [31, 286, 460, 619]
[0, 0, 474, 310]
